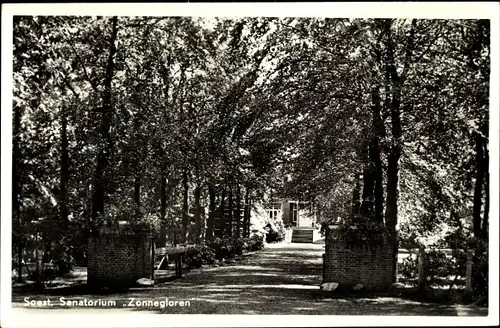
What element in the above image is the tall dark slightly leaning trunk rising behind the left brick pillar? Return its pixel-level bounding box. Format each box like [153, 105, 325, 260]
[92, 16, 118, 220]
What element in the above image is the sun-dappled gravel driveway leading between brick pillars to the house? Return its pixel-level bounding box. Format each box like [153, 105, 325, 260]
[12, 244, 487, 316]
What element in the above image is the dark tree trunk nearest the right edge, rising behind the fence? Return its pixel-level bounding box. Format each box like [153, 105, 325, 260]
[472, 133, 485, 238]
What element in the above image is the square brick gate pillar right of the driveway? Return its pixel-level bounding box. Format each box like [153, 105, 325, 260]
[324, 228, 393, 290]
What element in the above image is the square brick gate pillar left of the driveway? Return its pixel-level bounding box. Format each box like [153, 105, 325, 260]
[87, 231, 152, 286]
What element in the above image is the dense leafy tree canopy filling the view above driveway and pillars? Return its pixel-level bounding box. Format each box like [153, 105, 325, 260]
[13, 16, 490, 282]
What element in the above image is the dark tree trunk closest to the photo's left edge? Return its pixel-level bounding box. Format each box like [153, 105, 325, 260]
[12, 106, 24, 282]
